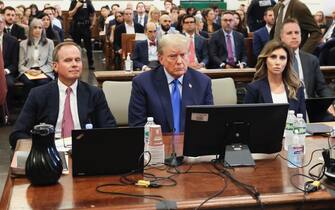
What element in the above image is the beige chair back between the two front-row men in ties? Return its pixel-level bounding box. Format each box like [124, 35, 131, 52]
[102, 81, 132, 126]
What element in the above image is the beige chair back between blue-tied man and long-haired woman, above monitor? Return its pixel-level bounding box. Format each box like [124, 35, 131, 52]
[212, 77, 237, 105]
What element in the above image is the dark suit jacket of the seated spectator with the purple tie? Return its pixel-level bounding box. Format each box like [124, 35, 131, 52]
[209, 29, 248, 69]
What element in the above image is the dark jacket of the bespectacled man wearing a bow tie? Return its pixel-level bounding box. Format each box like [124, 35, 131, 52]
[131, 40, 149, 70]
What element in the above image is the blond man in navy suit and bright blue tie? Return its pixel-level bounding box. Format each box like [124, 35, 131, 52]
[128, 34, 213, 132]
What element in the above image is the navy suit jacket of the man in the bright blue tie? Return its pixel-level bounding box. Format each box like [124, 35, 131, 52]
[128, 66, 213, 132]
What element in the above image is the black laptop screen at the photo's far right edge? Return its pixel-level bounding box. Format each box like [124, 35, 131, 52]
[305, 97, 335, 123]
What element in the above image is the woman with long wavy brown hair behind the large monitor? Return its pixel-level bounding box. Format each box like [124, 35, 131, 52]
[244, 41, 306, 120]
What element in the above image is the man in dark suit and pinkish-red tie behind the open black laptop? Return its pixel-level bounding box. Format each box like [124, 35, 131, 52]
[10, 42, 116, 148]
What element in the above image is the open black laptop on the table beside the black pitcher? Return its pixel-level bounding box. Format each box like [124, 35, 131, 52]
[72, 127, 144, 176]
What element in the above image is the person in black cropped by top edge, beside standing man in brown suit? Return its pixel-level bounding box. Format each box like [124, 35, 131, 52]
[247, 0, 276, 32]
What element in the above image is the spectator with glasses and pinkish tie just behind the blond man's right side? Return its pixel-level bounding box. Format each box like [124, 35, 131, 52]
[182, 15, 208, 69]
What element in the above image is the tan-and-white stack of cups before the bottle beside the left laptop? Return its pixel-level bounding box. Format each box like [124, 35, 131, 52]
[148, 125, 165, 166]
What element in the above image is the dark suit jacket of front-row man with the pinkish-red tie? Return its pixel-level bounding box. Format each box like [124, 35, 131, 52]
[9, 81, 116, 148]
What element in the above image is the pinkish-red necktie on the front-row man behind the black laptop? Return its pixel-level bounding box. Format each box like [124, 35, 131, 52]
[62, 87, 74, 138]
